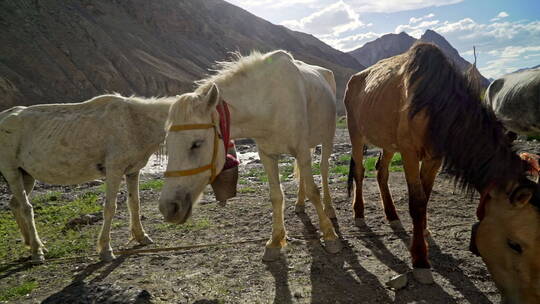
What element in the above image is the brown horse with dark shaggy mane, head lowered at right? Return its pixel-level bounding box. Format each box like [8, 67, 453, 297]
[345, 44, 540, 303]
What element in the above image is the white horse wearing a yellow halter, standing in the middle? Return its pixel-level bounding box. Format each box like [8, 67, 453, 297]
[159, 51, 341, 260]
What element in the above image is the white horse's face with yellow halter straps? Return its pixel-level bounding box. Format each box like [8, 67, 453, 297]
[159, 85, 225, 224]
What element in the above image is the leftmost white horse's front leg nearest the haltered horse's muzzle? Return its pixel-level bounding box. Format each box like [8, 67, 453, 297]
[126, 171, 153, 245]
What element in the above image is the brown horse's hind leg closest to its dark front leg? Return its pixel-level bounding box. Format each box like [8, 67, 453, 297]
[375, 150, 402, 228]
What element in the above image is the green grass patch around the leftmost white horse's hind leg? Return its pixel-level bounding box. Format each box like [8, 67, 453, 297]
[0, 192, 102, 261]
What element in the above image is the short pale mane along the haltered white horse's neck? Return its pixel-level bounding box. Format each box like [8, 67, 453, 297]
[195, 50, 293, 94]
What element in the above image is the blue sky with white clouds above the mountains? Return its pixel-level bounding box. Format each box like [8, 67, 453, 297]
[227, 0, 540, 78]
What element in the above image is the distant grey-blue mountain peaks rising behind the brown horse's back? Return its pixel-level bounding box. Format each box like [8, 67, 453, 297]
[349, 30, 489, 87]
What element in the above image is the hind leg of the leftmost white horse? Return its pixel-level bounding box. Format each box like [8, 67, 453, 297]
[4, 169, 45, 263]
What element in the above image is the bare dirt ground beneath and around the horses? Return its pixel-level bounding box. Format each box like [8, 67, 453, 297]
[0, 129, 537, 304]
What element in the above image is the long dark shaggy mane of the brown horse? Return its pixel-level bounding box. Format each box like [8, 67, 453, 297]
[403, 43, 528, 194]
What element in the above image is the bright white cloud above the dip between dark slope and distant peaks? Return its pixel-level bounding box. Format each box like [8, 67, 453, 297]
[282, 1, 365, 37]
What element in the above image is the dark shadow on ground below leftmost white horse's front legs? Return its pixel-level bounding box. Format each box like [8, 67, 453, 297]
[42, 255, 152, 304]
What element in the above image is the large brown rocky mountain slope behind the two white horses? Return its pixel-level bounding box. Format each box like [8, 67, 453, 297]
[0, 0, 363, 110]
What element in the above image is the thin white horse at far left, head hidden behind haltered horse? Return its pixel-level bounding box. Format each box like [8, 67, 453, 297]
[0, 95, 176, 262]
